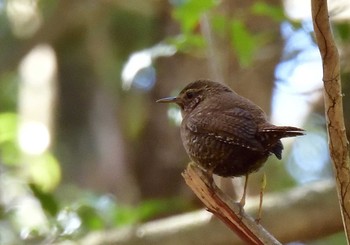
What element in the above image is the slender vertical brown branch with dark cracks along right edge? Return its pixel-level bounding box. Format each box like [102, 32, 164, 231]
[311, 0, 350, 241]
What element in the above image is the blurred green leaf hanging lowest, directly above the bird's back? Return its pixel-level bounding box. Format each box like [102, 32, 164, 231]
[231, 19, 258, 67]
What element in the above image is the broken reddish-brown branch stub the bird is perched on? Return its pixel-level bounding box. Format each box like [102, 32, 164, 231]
[183, 164, 281, 244]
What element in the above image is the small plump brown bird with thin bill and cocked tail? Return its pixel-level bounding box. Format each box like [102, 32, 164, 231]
[157, 80, 304, 206]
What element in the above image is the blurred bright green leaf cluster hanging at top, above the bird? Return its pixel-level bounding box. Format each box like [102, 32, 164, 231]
[170, 0, 285, 68]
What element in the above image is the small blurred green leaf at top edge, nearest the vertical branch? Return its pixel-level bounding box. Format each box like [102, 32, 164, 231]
[251, 1, 286, 22]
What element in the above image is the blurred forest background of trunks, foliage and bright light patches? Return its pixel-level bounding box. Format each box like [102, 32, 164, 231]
[0, 0, 350, 244]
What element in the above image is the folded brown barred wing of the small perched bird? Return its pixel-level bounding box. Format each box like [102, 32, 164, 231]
[186, 107, 263, 151]
